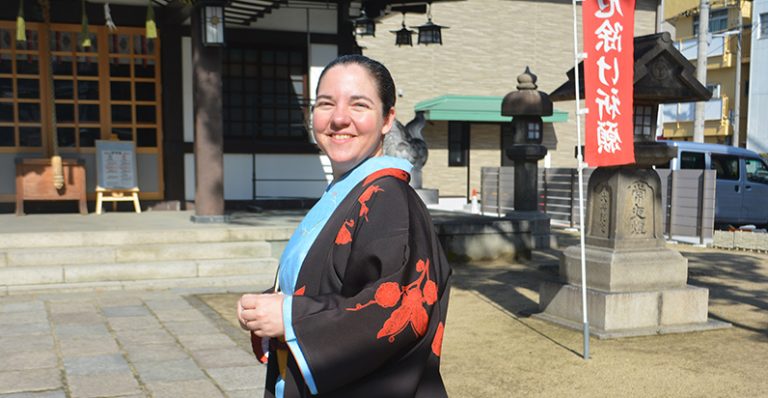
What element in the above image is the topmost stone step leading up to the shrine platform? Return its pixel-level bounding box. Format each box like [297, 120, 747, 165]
[0, 226, 293, 250]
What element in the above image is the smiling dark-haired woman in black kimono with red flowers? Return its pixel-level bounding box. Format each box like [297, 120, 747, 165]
[238, 55, 451, 397]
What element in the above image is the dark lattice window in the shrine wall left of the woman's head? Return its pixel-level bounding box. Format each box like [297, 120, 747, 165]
[222, 47, 309, 141]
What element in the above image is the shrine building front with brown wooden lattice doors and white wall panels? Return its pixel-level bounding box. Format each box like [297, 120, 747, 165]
[0, 0, 359, 210]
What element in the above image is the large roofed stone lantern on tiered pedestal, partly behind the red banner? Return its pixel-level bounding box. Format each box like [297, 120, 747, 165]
[537, 33, 728, 338]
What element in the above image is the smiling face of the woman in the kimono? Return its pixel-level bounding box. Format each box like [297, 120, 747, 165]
[312, 64, 395, 178]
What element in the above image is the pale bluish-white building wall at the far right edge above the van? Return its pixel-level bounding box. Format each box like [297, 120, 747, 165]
[747, 0, 768, 153]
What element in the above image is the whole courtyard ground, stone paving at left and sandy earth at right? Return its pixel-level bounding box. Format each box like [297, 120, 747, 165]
[0, 229, 768, 398]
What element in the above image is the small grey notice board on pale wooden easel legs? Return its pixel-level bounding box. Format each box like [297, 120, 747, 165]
[96, 140, 141, 214]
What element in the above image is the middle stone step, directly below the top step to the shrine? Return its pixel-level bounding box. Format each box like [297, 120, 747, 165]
[0, 241, 271, 267]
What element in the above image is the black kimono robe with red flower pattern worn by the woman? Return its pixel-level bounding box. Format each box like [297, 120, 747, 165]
[258, 158, 451, 397]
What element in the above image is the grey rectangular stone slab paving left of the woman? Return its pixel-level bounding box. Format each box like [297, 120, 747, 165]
[0, 290, 265, 398]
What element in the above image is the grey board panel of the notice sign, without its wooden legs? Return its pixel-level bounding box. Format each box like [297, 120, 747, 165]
[96, 140, 139, 190]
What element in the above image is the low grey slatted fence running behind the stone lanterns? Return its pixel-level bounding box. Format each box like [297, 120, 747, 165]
[480, 167, 715, 244]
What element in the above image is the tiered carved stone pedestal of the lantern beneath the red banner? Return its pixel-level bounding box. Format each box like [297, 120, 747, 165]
[537, 143, 729, 338]
